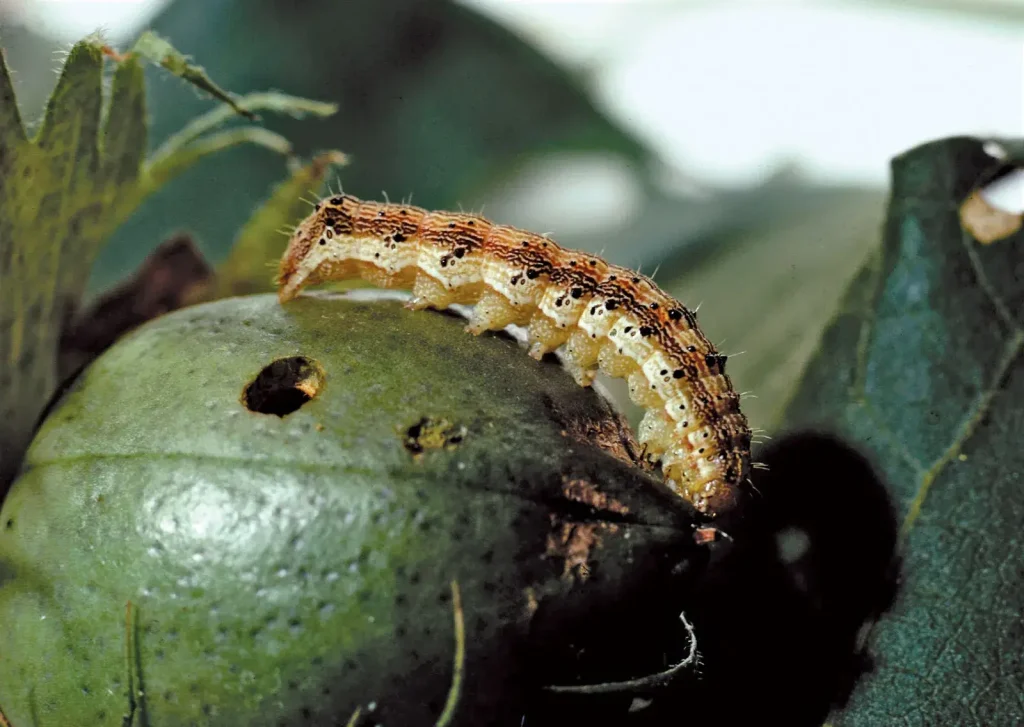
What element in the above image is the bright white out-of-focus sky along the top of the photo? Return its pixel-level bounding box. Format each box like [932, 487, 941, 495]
[12, 0, 1024, 209]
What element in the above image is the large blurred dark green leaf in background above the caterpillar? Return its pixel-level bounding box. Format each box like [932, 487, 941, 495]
[93, 0, 650, 289]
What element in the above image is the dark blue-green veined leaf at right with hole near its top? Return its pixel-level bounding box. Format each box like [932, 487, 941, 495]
[786, 138, 1024, 727]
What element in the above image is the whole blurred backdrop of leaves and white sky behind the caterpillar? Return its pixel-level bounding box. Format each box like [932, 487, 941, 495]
[0, 0, 1024, 432]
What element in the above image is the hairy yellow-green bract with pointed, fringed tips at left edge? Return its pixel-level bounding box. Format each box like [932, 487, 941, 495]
[0, 38, 342, 489]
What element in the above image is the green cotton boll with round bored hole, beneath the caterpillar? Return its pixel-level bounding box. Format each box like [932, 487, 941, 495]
[0, 294, 705, 727]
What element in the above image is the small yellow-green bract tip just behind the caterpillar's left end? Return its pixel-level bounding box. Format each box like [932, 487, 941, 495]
[214, 152, 345, 298]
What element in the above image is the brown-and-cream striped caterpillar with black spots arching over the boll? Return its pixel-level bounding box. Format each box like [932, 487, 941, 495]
[276, 195, 751, 516]
